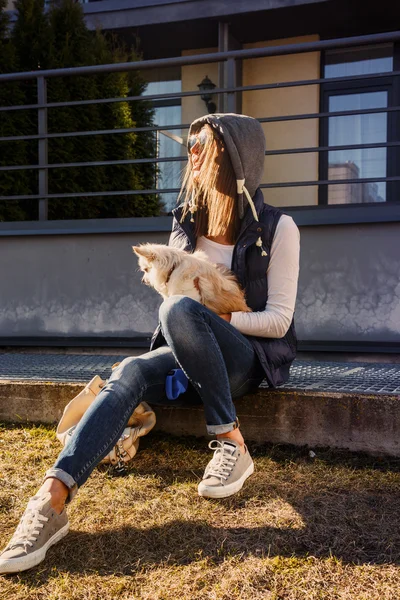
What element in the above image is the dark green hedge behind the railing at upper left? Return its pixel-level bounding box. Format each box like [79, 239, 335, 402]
[0, 0, 160, 221]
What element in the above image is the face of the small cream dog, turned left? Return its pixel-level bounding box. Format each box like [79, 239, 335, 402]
[132, 244, 177, 293]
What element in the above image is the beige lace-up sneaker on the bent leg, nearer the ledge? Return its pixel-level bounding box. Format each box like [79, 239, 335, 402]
[198, 439, 254, 498]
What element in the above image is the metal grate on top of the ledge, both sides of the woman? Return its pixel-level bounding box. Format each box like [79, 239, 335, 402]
[0, 353, 400, 395]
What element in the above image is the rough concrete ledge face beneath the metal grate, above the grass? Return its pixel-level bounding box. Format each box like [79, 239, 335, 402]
[0, 380, 400, 456]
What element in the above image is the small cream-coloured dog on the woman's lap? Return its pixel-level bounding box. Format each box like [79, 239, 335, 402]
[132, 244, 250, 314]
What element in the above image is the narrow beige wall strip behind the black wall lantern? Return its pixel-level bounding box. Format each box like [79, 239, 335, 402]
[182, 48, 218, 137]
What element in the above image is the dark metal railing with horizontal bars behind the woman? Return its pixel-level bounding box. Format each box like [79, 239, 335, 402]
[0, 31, 400, 220]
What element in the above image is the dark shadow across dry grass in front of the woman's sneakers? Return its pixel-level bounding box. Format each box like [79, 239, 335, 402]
[13, 480, 400, 587]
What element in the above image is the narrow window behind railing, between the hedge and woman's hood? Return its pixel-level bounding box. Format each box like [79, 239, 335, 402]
[143, 69, 186, 213]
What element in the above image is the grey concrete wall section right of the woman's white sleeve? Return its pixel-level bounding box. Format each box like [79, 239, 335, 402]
[296, 223, 400, 342]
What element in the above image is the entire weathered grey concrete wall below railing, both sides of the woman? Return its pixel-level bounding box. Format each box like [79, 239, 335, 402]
[0, 223, 400, 347]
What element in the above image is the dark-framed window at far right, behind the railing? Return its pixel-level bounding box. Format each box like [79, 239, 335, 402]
[320, 44, 398, 204]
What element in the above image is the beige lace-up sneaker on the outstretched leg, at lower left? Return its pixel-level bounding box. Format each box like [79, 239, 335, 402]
[0, 490, 69, 574]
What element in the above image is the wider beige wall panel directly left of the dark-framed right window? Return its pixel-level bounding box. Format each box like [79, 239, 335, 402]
[243, 35, 320, 206]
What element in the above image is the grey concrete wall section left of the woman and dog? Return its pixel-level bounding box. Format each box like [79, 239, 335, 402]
[0, 233, 168, 337]
